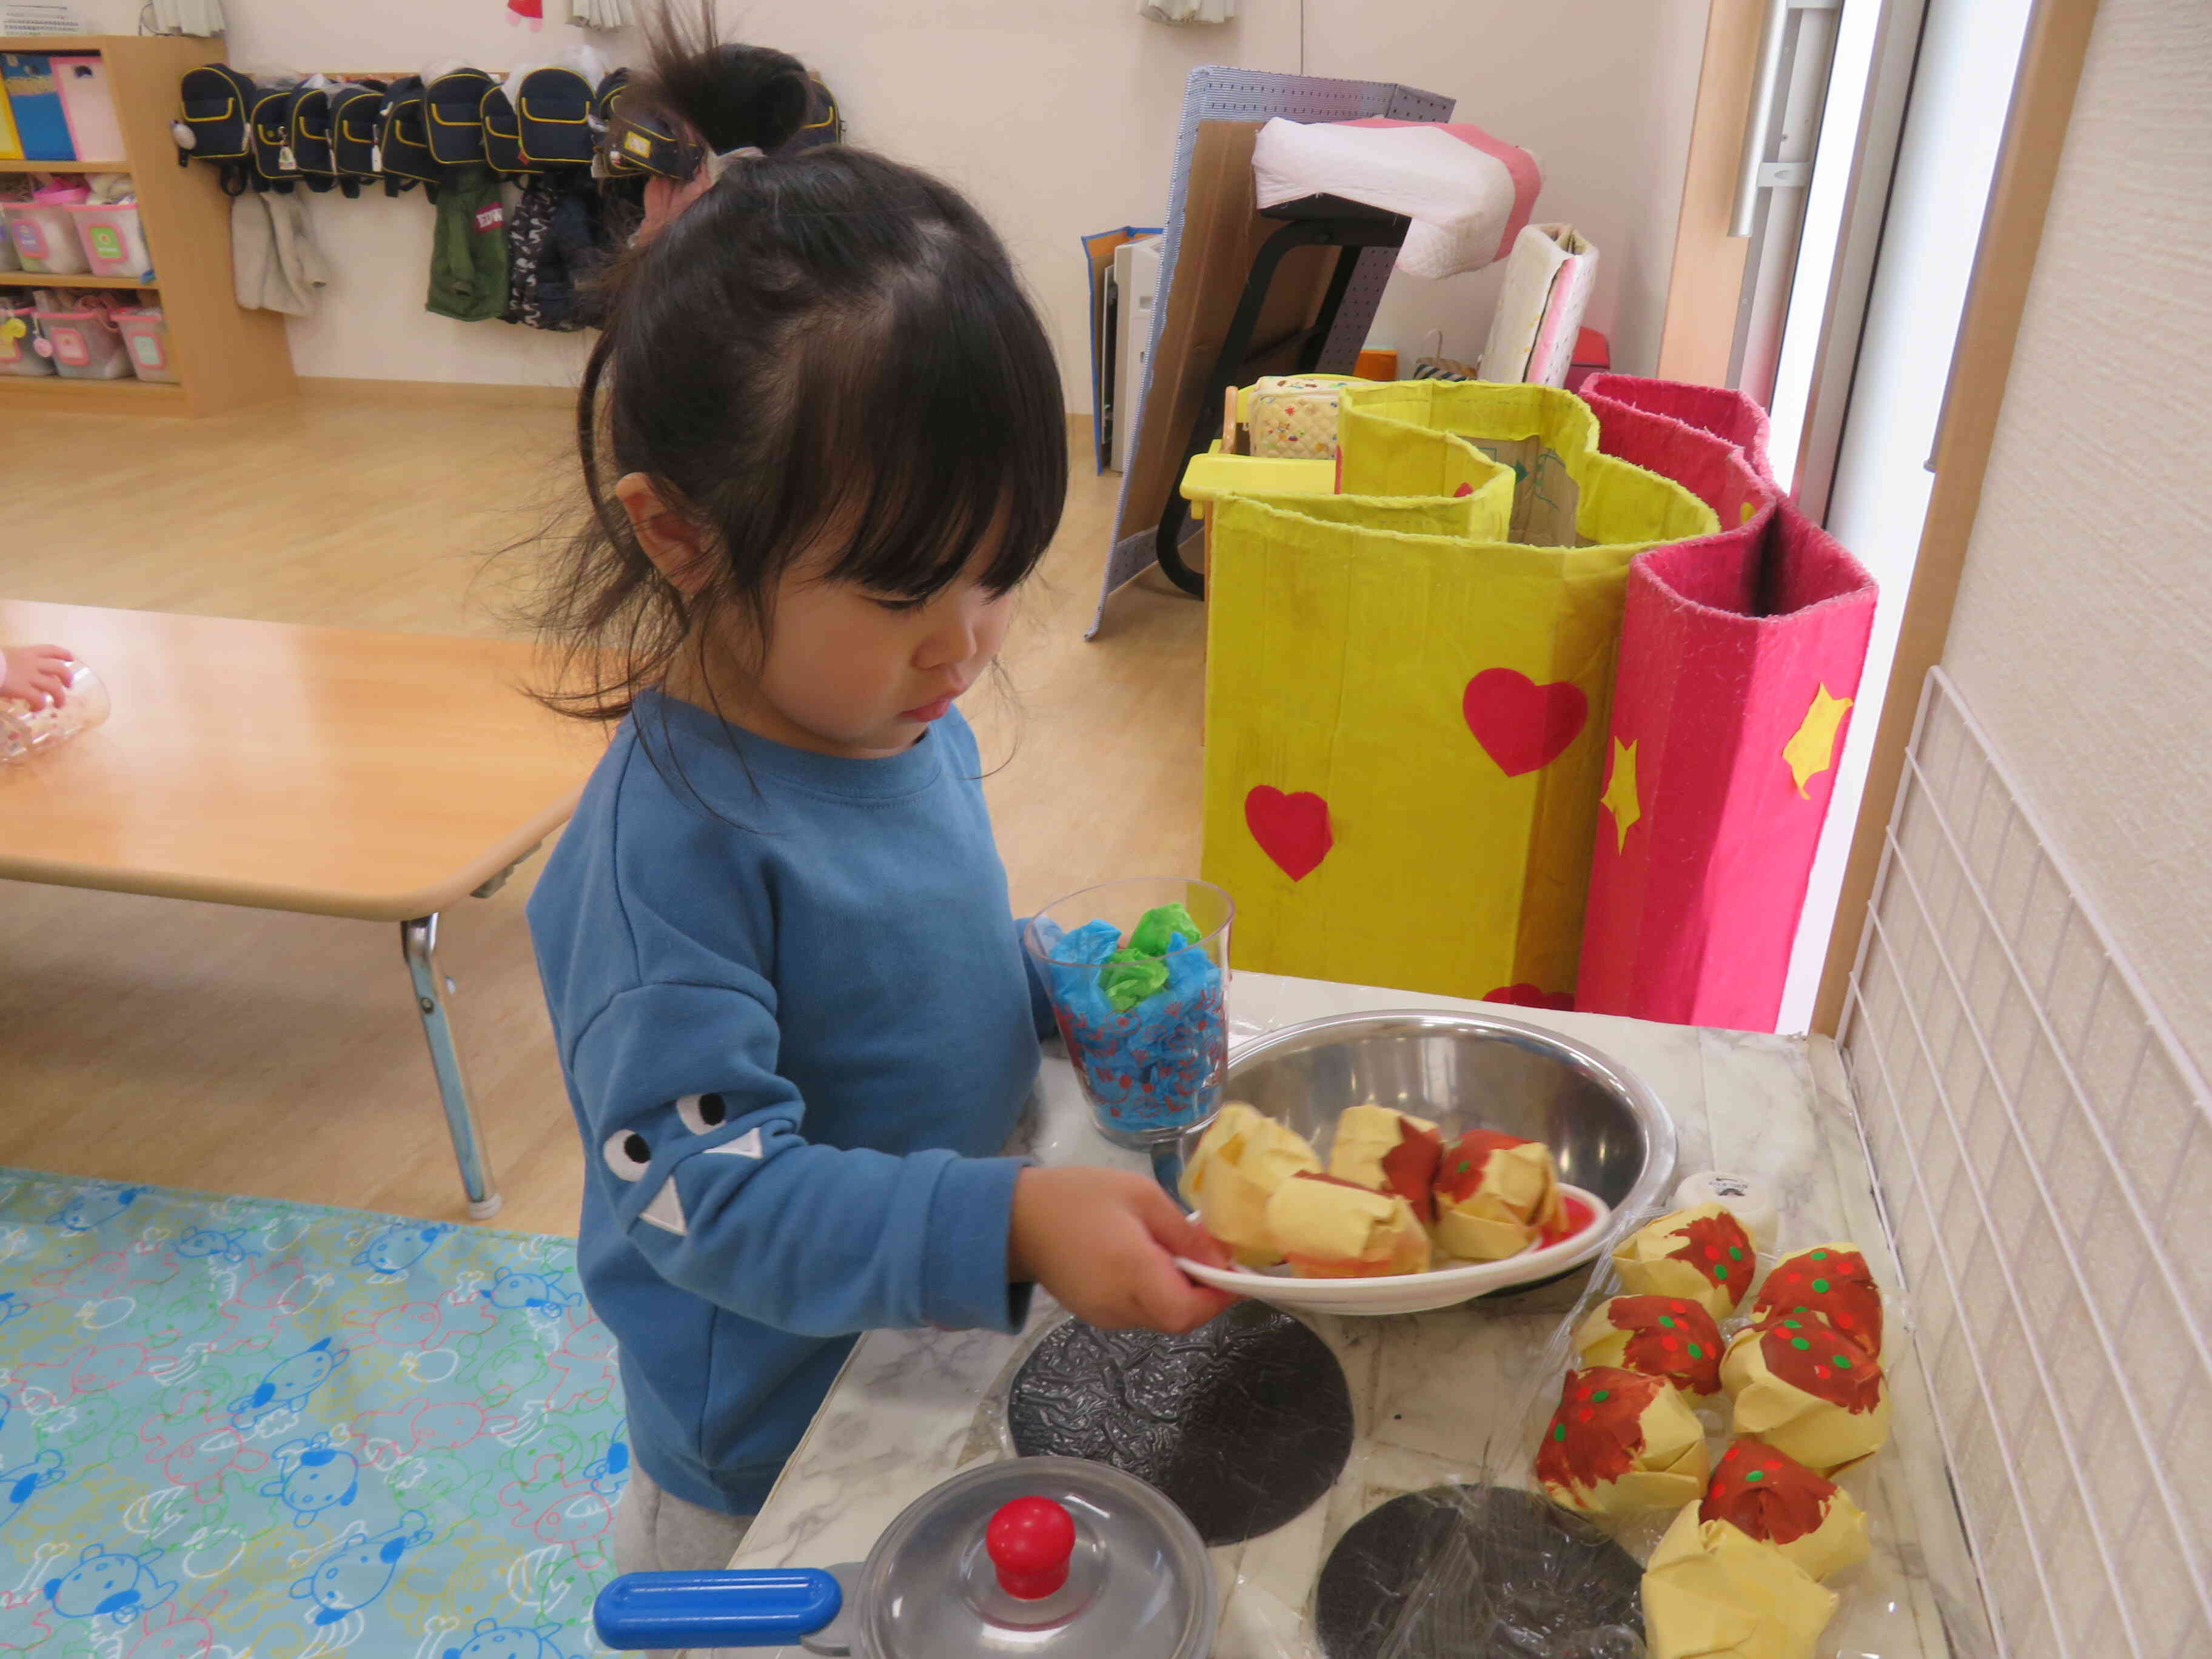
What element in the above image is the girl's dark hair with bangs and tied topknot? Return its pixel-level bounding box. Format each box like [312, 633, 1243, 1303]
[531, 9, 1068, 752]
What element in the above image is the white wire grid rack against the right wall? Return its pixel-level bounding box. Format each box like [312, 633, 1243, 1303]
[1840, 668, 2212, 1659]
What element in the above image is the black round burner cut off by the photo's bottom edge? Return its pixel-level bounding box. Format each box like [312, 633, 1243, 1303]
[1314, 1486, 1643, 1659]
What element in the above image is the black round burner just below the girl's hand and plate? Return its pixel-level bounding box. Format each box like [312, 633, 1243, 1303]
[1007, 1303, 1352, 1544]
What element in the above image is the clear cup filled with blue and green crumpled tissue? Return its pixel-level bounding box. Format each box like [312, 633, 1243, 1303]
[1022, 876, 1236, 1150]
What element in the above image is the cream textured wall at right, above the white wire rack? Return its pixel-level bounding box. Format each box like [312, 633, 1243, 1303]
[1945, 0, 2212, 1064]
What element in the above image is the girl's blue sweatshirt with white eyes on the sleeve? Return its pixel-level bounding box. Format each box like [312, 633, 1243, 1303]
[529, 692, 1048, 1515]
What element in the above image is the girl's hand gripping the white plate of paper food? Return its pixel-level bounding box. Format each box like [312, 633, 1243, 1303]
[1007, 1168, 1236, 1332]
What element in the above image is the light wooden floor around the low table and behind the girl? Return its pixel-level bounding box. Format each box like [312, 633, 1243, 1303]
[0, 383, 1204, 1232]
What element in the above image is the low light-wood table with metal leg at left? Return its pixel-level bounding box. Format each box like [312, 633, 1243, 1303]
[0, 600, 604, 1219]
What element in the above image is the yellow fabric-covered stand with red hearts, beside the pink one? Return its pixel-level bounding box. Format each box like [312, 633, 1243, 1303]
[1204, 380, 1718, 1007]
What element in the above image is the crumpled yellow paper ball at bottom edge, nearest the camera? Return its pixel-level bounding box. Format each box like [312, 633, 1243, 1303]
[1643, 1509, 1836, 1659]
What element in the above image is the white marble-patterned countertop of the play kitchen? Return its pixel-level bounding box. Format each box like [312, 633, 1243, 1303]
[699, 973, 1993, 1659]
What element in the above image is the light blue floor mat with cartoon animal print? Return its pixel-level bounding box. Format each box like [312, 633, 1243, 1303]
[0, 1170, 628, 1659]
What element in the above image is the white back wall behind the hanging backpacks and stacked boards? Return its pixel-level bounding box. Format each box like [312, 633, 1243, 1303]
[82, 0, 1706, 409]
